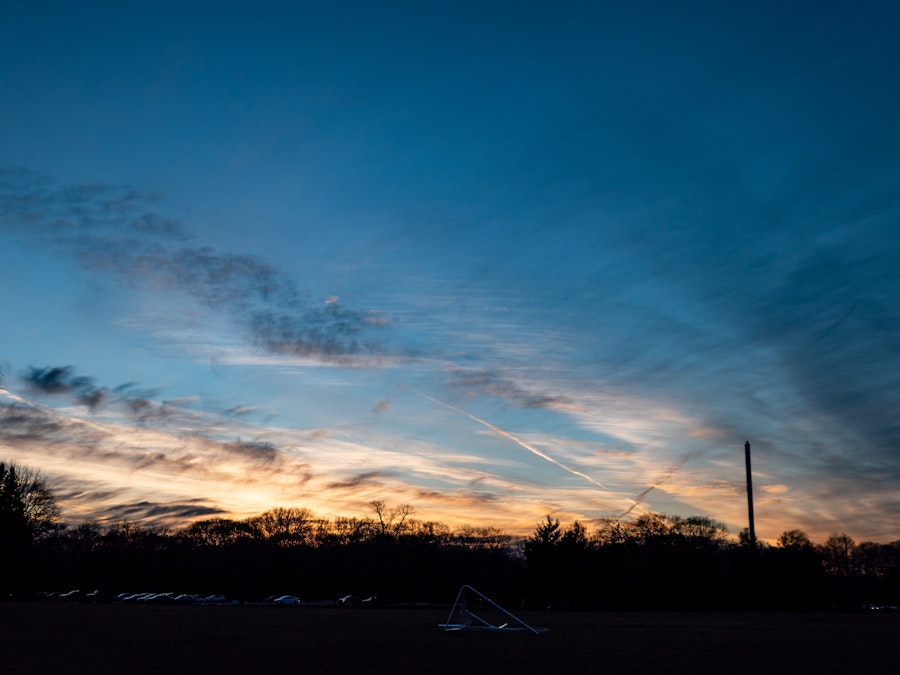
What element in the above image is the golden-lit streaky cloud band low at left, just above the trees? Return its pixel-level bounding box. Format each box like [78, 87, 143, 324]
[0, 380, 536, 525]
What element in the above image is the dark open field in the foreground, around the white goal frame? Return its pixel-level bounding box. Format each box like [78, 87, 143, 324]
[0, 602, 900, 674]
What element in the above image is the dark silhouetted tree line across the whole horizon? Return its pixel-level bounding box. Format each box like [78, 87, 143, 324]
[0, 462, 900, 610]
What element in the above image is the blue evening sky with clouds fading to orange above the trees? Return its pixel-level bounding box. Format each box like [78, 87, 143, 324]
[0, 0, 900, 542]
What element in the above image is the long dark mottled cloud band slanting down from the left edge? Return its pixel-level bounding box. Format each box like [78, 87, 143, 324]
[0, 171, 387, 363]
